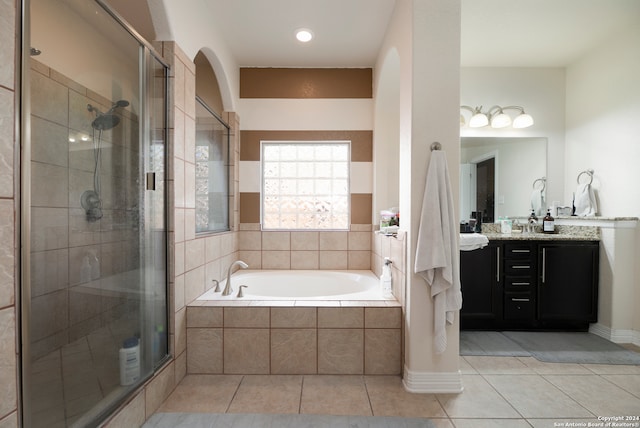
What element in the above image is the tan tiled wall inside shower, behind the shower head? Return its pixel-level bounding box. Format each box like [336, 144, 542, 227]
[30, 60, 140, 359]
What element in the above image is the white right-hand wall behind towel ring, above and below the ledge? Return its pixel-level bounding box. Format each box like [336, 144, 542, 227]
[564, 23, 640, 334]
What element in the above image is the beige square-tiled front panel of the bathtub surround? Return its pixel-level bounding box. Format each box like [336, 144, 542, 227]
[187, 301, 402, 375]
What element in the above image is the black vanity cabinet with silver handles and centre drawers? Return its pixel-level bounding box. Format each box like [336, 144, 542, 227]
[460, 240, 599, 330]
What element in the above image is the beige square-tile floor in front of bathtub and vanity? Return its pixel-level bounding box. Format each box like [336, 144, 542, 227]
[158, 348, 640, 428]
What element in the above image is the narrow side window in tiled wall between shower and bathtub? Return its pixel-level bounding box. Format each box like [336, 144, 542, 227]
[195, 97, 230, 233]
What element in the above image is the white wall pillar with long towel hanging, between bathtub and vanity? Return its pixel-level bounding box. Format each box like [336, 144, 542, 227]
[374, 0, 462, 392]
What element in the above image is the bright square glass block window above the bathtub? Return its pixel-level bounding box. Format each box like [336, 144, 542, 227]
[261, 141, 351, 230]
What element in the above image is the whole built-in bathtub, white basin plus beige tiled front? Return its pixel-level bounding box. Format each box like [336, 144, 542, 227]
[186, 269, 403, 376]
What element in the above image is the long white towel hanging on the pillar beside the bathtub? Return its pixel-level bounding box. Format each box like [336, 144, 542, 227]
[414, 150, 462, 354]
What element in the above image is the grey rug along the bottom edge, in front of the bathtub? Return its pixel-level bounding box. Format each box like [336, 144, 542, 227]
[142, 413, 435, 428]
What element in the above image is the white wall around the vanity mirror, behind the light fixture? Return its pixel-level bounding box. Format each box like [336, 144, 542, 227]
[460, 67, 571, 205]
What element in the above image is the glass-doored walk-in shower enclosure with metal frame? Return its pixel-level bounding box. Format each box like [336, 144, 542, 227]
[20, 0, 168, 427]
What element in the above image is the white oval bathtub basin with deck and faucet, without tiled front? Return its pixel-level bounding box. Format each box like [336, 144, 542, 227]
[197, 270, 393, 300]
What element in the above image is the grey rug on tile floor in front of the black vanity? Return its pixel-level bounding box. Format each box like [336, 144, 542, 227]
[460, 331, 640, 365]
